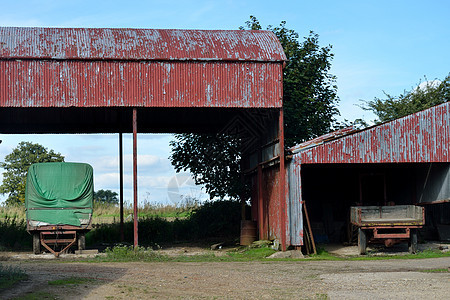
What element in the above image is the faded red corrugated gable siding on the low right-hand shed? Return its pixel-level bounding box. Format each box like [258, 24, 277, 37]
[296, 103, 450, 164]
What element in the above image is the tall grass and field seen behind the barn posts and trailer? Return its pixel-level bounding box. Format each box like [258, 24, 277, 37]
[0, 200, 211, 251]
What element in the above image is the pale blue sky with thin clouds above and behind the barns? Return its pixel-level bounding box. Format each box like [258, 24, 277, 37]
[0, 0, 450, 204]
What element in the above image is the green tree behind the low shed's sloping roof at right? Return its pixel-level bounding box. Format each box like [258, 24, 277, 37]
[362, 74, 450, 123]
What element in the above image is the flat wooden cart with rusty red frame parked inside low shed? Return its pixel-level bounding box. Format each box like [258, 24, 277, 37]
[350, 205, 425, 254]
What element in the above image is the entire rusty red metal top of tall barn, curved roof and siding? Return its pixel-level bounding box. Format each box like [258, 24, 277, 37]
[0, 27, 286, 108]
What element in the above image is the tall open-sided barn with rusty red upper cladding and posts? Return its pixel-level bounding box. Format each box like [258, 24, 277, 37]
[0, 27, 286, 245]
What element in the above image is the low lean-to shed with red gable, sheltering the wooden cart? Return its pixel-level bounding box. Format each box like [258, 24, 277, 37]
[286, 103, 450, 246]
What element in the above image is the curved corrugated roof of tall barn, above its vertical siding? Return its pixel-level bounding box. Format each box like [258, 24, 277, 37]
[0, 27, 286, 62]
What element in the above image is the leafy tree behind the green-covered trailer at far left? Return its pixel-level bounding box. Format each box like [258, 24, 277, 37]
[0, 142, 64, 205]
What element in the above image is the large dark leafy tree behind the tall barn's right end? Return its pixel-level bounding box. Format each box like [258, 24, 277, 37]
[169, 16, 339, 199]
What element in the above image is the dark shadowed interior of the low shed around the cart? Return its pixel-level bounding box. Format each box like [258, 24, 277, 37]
[302, 163, 450, 243]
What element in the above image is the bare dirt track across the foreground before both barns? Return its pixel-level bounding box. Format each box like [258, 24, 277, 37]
[0, 257, 450, 299]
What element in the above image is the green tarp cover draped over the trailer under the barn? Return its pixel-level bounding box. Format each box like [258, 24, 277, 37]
[25, 162, 94, 226]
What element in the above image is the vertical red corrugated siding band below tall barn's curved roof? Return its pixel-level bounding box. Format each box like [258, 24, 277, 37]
[0, 60, 282, 108]
